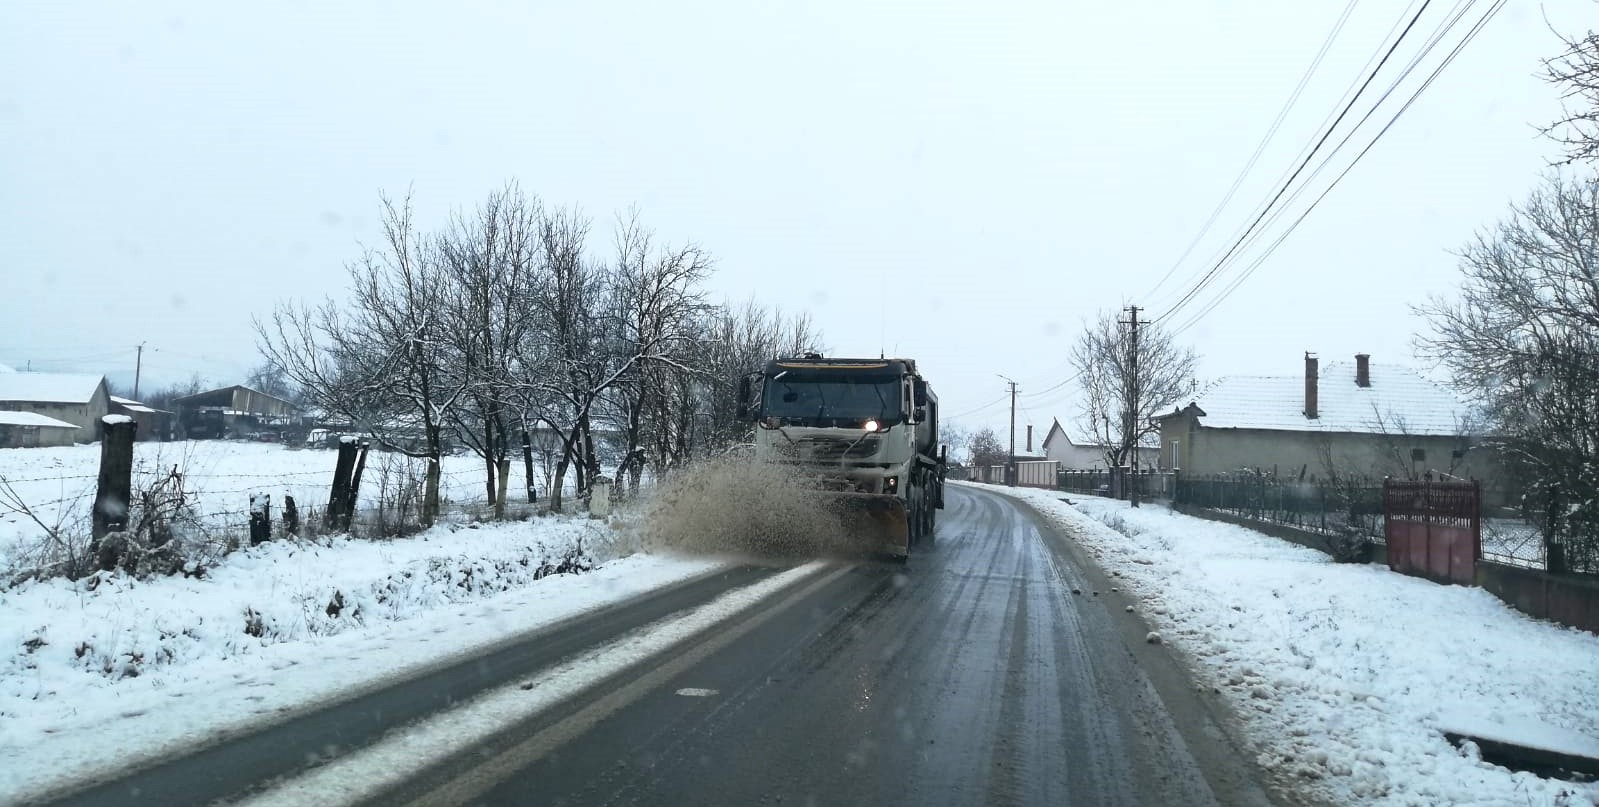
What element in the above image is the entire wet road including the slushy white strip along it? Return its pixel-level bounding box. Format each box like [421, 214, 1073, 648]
[31, 487, 1266, 805]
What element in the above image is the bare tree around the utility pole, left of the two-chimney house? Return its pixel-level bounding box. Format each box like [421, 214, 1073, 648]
[1071, 312, 1198, 485]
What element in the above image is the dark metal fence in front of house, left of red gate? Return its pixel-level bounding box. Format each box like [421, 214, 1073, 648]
[1172, 475, 1383, 542]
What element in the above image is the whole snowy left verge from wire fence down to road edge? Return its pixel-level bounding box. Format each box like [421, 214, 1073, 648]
[0, 508, 718, 804]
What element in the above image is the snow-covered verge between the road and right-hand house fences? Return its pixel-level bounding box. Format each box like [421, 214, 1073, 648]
[983, 486, 1599, 805]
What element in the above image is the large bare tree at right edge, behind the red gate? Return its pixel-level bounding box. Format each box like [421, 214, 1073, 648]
[1418, 174, 1599, 569]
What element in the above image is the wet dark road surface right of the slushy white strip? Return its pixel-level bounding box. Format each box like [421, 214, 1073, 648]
[376, 486, 1263, 805]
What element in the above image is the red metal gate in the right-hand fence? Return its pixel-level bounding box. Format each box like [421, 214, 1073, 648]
[1383, 479, 1482, 585]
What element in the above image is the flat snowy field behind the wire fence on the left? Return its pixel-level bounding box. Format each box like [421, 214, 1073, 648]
[0, 439, 542, 570]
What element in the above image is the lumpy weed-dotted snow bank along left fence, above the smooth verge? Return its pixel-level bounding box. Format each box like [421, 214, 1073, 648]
[0, 518, 609, 699]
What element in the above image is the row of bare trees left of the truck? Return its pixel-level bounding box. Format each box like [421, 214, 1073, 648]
[256, 185, 819, 524]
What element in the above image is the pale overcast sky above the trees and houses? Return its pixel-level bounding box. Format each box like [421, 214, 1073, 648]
[0, 0, 1599, 441]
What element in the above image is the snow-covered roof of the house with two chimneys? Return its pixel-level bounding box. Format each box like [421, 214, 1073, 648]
[1170, 361, 1468, 435]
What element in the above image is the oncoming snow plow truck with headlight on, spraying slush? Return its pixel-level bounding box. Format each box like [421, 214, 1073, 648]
[739, 353, 948, 561]
